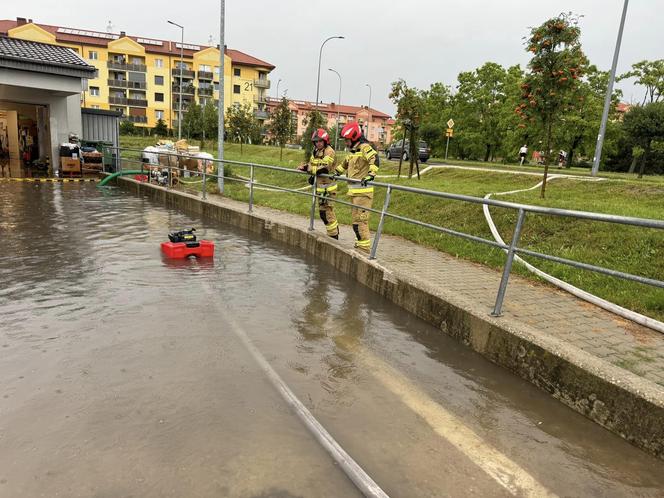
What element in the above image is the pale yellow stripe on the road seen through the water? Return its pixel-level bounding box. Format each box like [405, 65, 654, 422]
[358, 350, 557, 498]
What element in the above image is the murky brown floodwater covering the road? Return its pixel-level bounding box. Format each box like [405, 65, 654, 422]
[0, 183, 664, 498]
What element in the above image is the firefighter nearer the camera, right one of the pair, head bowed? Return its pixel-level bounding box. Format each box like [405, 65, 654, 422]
[335, 122, 378, 253]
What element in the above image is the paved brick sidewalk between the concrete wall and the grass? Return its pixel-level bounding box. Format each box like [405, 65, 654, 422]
[211, 196, 664, 396]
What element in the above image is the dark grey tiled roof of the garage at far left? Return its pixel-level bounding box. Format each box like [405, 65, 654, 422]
[0, 36, 96, 76]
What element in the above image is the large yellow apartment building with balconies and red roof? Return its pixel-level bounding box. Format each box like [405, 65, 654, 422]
[0, 18, 274, 128]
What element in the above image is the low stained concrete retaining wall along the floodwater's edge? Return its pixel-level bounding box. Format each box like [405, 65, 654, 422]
[118, 178, 664, 460]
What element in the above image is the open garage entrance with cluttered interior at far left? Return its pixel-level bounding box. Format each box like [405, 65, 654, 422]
[0, 101, 52, 178]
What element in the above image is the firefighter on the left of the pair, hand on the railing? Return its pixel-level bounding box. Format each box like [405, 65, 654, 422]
[298, 128, 339, 239]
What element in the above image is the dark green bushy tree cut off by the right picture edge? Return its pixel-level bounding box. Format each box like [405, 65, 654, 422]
[623, 102, 664, 178]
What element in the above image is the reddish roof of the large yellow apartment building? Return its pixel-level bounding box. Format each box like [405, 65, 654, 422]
[0, 19, 275, 71]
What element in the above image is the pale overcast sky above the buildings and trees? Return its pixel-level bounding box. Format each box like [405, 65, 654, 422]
[6, 0, 664, 113]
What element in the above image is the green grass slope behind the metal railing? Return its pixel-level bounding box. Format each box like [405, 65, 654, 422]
[123, 138, 664, 320]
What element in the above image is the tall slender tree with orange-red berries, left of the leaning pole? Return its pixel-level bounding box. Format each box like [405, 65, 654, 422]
[516, 13, 588, 197]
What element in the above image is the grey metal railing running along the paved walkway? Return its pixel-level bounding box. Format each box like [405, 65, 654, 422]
[102, 147, 664, 317]
